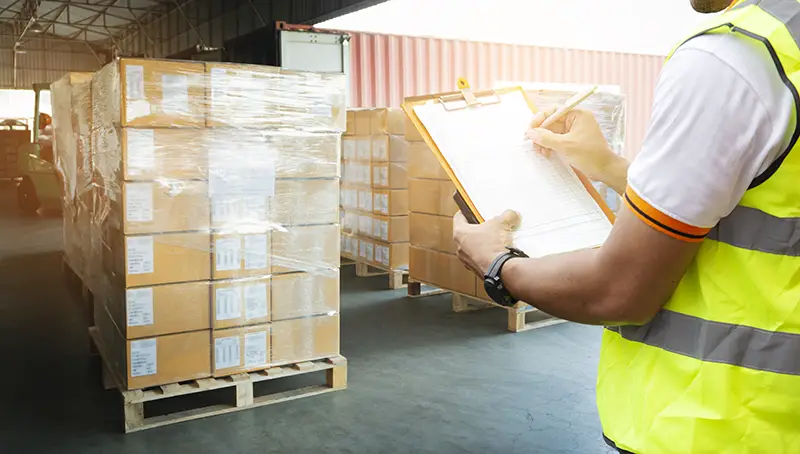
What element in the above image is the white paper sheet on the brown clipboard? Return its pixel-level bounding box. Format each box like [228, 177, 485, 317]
[414, 90, 611, 257]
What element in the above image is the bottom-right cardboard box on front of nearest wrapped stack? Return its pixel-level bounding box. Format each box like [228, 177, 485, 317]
[272, 315, 339, 365]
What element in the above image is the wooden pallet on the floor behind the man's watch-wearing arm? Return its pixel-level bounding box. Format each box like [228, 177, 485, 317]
[408, 280, 566, 333]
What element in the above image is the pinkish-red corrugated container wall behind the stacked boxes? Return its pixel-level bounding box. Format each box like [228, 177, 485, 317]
[350, 32, 664, 157]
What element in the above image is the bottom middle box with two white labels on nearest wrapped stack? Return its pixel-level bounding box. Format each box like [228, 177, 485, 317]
[211, 324, 272, 377]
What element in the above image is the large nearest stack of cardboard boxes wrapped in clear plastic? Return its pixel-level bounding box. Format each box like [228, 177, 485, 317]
[53, 59, 346, 389]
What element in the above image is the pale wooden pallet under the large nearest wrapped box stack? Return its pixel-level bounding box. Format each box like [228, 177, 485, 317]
[89, 327, 347, 433]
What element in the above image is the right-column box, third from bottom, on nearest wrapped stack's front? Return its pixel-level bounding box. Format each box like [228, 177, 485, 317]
[272, 224, 340, 273]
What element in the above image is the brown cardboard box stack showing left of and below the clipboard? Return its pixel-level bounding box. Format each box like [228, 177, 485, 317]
[406, 122, 490, 301]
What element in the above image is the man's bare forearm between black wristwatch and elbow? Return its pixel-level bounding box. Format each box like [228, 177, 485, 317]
[502, 249, 628, 325]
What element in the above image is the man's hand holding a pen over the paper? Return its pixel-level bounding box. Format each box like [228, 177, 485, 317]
[527, 109, 628, 194]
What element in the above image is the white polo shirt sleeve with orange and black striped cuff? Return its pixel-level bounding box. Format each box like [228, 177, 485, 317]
[626, 34, 796, 241]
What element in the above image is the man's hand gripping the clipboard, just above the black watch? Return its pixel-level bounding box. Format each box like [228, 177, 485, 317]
[453, 210, 520, 277]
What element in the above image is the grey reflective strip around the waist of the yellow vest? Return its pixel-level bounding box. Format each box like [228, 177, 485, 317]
[606, 310, 800, 375]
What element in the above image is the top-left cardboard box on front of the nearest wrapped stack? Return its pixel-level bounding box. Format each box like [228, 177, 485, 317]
[119, 58, 206, 128]
